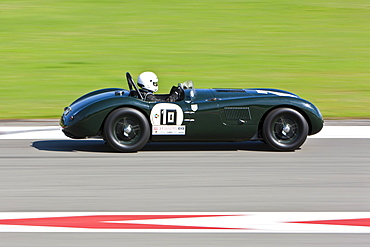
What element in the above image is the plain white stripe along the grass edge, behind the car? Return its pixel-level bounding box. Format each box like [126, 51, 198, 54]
[0, 126, 370, 140]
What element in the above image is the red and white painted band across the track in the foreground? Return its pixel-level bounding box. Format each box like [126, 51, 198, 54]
[0, 212, 370, 233]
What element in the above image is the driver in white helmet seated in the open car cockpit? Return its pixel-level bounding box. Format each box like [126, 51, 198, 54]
[137, 71, 179, 102]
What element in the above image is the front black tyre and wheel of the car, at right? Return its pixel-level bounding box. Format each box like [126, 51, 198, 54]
[262, 108, 308, 151]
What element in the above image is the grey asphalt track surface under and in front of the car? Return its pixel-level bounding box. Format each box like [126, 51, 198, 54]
[0, 119, 370, 246]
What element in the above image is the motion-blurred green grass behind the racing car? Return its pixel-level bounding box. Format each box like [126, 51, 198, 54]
[0, 0, 370, 119]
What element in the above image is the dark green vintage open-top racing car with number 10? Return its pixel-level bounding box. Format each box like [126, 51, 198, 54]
[60, 73, 324, 152]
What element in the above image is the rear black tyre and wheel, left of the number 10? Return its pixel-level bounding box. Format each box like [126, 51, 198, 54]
[103, 108, 150, 152]
